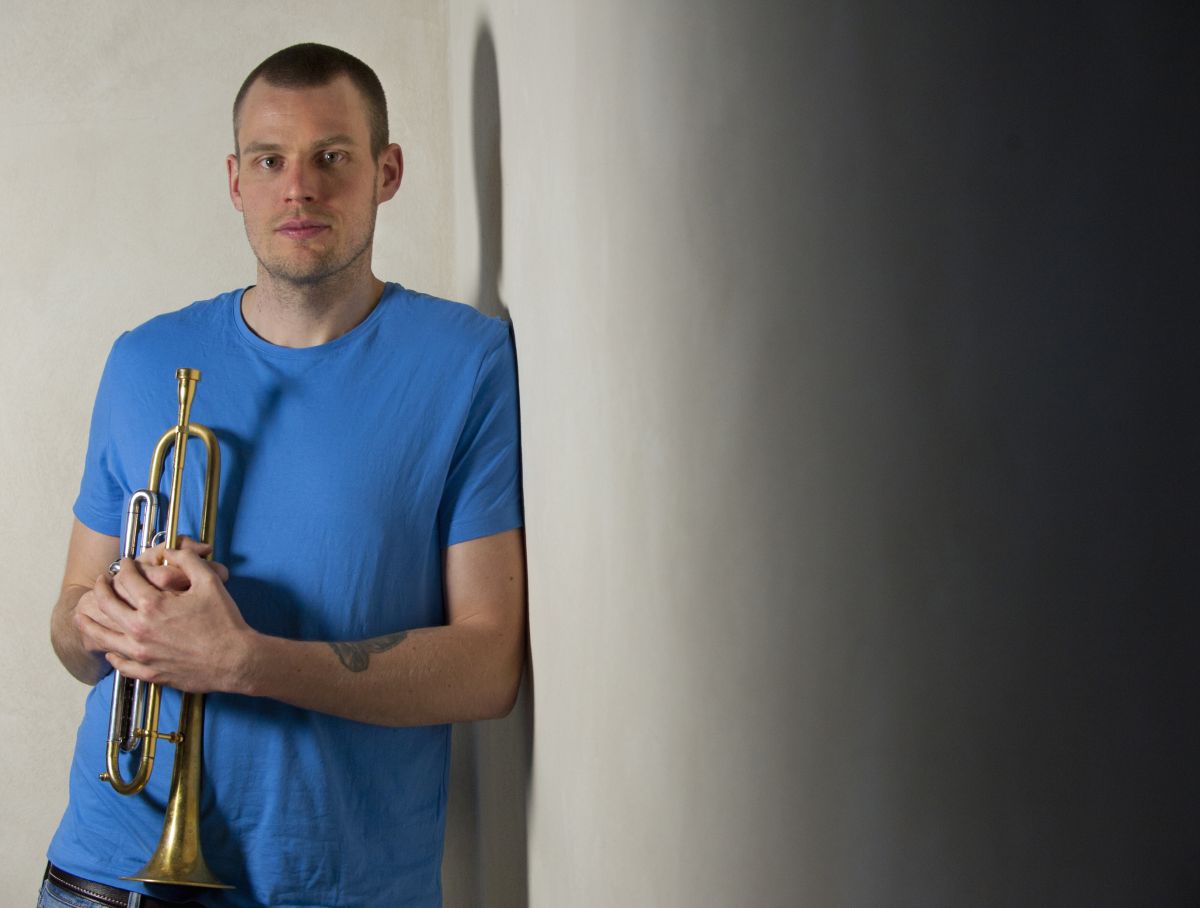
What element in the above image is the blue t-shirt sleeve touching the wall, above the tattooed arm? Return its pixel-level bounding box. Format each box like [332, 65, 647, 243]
[438, 330, 523, 546]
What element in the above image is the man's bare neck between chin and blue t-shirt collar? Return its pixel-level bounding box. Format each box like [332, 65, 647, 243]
[241, 266, 384, 347]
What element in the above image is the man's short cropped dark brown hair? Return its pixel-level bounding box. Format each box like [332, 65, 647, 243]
[233, 43, 388, 157]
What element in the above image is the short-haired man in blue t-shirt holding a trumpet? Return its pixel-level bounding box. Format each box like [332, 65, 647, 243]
[42, 44, 524, 906]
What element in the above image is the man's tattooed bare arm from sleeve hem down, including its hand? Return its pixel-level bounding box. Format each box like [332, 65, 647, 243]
[80, 530, 526, 726]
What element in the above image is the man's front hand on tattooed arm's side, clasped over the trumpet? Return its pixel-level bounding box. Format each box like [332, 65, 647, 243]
[74, 540, 254, 693]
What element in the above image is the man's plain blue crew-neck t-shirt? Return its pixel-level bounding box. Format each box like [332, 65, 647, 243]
[49, 284, 522, 908]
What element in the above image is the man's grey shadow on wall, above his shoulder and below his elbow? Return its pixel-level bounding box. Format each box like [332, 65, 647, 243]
[442, 22, 533, 908]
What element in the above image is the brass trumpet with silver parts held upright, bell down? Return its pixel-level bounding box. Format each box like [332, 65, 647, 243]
[100, 369, 233, 889]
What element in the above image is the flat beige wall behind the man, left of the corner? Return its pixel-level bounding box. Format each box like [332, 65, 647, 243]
[0, 0, 451, 904]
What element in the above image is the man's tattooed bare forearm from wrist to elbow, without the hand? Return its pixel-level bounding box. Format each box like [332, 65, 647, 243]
[233, 621, 524, 726]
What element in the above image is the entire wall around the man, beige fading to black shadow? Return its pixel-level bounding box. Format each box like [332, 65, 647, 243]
[0, 0, 1200, 908]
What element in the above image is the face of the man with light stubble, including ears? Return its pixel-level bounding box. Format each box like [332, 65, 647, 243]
[228, 76, 400, 285]
